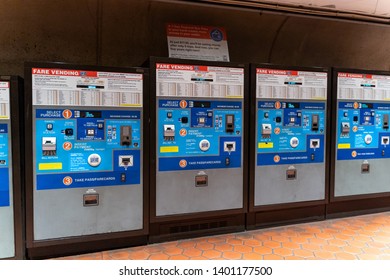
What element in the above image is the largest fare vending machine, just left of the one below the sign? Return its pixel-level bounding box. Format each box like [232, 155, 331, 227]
[25, 63, 148, 258]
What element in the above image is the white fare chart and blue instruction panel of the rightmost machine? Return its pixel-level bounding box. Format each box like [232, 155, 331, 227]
[336, 73, 390, 160]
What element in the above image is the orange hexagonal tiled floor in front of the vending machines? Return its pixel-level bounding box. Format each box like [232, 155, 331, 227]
[54, 212, 390, 260]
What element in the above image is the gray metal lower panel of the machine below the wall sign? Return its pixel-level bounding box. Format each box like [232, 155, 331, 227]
[156, 168, 243, 216]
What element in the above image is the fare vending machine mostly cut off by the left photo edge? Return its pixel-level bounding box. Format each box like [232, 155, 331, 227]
[0, 76, 25, 260]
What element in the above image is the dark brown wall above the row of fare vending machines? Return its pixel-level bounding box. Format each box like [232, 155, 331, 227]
[0, 0, 390, 76]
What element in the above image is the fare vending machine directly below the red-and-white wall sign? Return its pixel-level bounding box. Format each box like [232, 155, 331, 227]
[150, 58, 248, 241]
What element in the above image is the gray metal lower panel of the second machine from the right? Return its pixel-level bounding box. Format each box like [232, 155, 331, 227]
[255, 163, 325, 206]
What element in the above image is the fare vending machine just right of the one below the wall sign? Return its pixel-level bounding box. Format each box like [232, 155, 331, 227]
[247, 64, 330, 228]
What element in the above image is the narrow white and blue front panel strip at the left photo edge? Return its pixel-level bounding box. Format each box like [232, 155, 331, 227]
[0, 81, 11, 207]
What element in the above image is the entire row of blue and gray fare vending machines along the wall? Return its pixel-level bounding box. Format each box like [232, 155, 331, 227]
[0, 58, 390, 259]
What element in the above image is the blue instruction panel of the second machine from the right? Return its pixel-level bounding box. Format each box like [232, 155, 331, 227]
[257, 101, 326, 166]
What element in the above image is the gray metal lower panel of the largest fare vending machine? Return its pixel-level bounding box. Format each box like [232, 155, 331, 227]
[34, 185, 143, 240]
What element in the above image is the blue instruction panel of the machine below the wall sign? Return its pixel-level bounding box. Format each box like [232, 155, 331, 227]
[157, 99, 243, 171]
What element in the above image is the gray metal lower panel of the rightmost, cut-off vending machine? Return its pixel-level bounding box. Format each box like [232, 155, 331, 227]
[334, 159, 390, 197]
